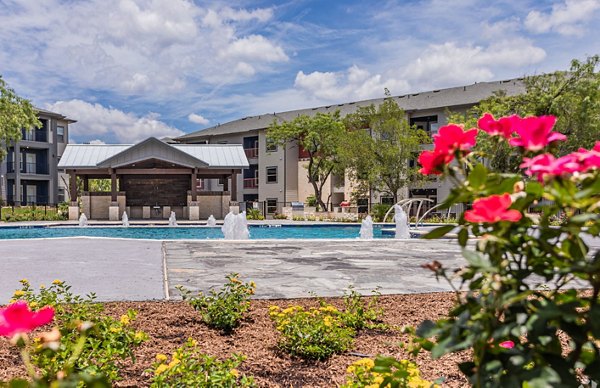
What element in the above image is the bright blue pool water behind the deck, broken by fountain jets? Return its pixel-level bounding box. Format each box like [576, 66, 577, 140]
[0, 225, 393, 240]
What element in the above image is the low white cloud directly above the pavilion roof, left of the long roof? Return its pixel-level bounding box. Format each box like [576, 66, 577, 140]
[47, 100, 184, 143]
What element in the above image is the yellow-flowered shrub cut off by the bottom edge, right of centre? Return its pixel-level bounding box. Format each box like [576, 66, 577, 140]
[341, 357, 435, 388]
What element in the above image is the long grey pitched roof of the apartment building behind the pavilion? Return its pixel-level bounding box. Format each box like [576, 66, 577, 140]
[175, 79, 525, 142]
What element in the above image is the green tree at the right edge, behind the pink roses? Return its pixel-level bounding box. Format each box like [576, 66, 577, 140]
[448, 55, 600, 172]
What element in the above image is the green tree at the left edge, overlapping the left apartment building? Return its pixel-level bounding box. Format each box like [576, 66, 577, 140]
[0, 76, 42, 161]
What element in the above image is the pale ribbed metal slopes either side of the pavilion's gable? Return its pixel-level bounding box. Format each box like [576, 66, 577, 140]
[58, 139, 248, 169]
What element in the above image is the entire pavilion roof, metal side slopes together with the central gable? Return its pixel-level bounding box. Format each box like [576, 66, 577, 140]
[58, 137, 248, 169]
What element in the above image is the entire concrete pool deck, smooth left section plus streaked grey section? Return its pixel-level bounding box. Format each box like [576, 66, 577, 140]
[0, 237, 464, 303]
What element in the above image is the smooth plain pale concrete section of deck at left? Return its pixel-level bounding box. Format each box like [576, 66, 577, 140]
[0, 237, 165, 303]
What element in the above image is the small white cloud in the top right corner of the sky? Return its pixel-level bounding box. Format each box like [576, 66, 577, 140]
[525, 0, 600, 35]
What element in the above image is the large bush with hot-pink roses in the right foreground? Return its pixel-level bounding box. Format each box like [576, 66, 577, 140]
[417, 114, 600, 387]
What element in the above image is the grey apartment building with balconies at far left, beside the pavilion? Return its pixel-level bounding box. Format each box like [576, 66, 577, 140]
[0, 108, 75, 206]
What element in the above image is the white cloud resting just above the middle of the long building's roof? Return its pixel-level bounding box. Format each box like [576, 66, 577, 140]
[294, 65, 408, 101]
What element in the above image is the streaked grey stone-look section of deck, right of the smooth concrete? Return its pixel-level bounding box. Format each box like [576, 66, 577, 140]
[165, 239, 464, 298]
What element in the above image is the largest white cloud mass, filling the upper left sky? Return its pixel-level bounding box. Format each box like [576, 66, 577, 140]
[0, 0, 288, 101]
